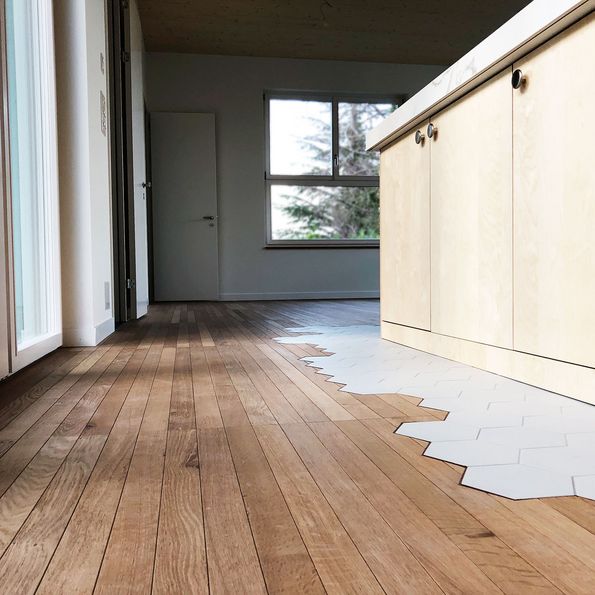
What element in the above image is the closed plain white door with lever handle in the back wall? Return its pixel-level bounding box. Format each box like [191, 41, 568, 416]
[151, 113, 219, 301]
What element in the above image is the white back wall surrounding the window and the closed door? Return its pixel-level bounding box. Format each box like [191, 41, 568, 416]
[146, 53, 443, 299]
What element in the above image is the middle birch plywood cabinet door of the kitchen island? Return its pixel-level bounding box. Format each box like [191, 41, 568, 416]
[430, 70, 512, 348]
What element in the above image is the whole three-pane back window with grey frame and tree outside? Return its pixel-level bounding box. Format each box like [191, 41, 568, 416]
[265, 93, 397, 246]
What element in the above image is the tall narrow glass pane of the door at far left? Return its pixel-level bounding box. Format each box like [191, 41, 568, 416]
[6, 0, 50, 348]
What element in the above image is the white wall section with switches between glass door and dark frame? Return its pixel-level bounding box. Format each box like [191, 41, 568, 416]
[54, 0, 114, 345]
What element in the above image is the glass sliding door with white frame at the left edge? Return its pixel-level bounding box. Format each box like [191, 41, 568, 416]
[4, 0, 61, 371]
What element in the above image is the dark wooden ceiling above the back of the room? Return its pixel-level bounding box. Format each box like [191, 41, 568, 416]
[138, 0, 529, 64]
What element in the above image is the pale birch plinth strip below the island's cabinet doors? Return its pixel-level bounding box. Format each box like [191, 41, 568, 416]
[381, 322, 595, 404]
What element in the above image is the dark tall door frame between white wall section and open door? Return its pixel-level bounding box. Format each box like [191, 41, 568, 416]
[107, 0, 136, 324]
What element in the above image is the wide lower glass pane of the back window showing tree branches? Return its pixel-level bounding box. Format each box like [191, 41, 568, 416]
[271, 184, 380, 240]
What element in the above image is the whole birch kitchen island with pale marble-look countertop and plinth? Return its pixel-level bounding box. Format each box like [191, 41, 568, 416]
[368, 0, 595, 403]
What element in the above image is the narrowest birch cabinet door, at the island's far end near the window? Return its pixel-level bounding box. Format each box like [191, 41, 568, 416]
[380, 122, 430, 330]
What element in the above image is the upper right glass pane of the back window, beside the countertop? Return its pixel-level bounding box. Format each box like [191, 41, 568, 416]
[339, 102, 396, 176]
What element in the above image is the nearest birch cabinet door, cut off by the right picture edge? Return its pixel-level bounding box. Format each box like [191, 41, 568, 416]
[513, 14, 595, 366]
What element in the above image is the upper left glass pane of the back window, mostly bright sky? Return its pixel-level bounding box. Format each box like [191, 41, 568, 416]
[269, 99, 333, 176]
